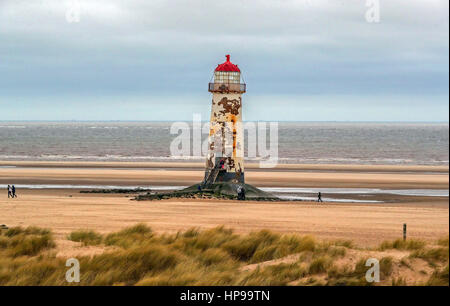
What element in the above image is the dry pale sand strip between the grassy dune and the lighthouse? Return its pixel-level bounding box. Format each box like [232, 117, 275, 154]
[0, 190, 449, 245]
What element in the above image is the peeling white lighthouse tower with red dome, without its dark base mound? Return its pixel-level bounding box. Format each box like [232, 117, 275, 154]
[203, 55, 246, 185]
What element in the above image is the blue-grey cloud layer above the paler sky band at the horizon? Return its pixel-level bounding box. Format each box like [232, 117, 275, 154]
[0, 0, 449, 119]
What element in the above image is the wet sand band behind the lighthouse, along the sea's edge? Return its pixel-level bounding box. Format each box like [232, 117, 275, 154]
[0, 162, 449, 189]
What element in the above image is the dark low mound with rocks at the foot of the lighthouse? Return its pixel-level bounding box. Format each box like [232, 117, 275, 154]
[136, 182, 280, 201]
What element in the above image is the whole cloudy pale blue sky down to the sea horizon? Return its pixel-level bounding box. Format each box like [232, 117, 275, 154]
[0, 0, 449, 122]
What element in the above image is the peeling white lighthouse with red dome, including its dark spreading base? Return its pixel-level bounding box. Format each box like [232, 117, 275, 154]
[146, 55, 279, 201]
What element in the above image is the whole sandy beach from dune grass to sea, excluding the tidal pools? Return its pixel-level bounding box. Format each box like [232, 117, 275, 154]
[0, 162, 449, 245]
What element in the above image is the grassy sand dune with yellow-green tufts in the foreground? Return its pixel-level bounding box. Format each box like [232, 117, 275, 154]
[0, 224, 449, 286]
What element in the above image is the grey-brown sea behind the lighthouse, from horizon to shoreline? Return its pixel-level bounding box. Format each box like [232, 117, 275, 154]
[0, 121, 449, 165]
